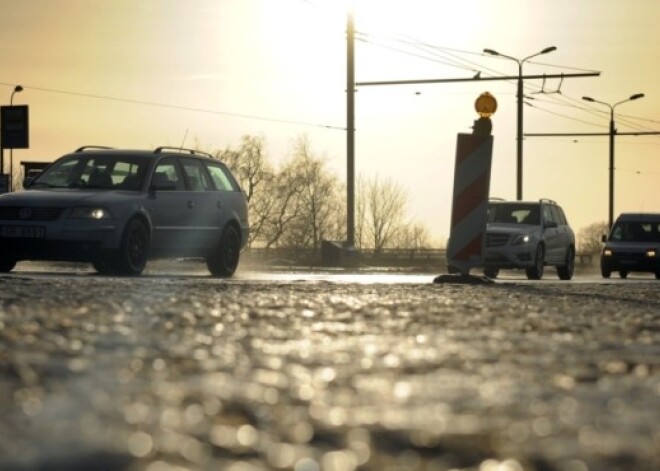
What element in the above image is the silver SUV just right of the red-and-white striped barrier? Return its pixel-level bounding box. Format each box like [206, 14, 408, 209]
[484, 199, 575, 280]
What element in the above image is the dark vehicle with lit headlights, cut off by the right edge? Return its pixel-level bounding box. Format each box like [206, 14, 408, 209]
[600, 213, 660, 279]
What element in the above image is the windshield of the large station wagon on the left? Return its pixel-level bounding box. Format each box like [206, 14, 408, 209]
[30, 154, 148, 191]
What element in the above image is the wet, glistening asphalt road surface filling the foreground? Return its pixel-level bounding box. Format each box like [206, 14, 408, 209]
[0, 269, 660, 471]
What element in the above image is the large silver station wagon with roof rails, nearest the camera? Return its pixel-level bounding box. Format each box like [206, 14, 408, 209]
[0, 146, 249, 277]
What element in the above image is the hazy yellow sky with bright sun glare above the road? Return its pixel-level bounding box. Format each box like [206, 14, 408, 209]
[0, 0, 660, 242]
